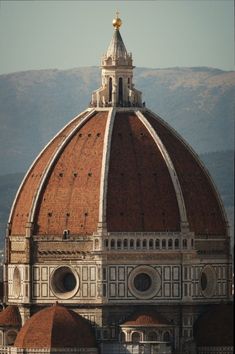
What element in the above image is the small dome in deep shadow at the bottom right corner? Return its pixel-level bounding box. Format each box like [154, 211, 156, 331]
[194, 304, 234, 347]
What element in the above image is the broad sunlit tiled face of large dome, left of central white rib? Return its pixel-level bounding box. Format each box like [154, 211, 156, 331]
[34, 112, 107, 235]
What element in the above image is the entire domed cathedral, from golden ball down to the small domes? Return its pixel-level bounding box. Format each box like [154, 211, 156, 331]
[0, 12, 233, 354]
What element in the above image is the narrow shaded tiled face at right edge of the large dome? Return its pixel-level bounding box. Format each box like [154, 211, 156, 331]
[146, 113, 226, 235]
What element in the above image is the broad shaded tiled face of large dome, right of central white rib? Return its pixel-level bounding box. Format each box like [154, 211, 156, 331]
[107, 112, 180, 232]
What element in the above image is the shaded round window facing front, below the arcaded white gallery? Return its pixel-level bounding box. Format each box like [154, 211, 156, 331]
[128, 266, 161, 299]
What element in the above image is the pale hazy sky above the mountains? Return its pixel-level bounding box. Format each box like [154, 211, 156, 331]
[0, 0, 235, 74]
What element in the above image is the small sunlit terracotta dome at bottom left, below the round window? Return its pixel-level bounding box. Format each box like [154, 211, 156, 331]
[14, 304, 96, 348]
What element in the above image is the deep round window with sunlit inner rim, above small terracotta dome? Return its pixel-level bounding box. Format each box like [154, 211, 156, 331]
[51, 266, 79, 299]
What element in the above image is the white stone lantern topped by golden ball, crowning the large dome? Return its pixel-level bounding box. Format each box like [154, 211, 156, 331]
[91, 12, 142, 107]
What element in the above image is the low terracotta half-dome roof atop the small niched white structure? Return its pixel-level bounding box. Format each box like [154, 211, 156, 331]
[122, 312, 170, 327]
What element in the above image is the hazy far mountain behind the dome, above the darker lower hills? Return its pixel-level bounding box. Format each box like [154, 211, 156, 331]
[0, 67, 235, 174]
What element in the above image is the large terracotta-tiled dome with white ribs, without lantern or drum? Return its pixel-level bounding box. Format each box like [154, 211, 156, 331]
[9, 108, 227, 236]
